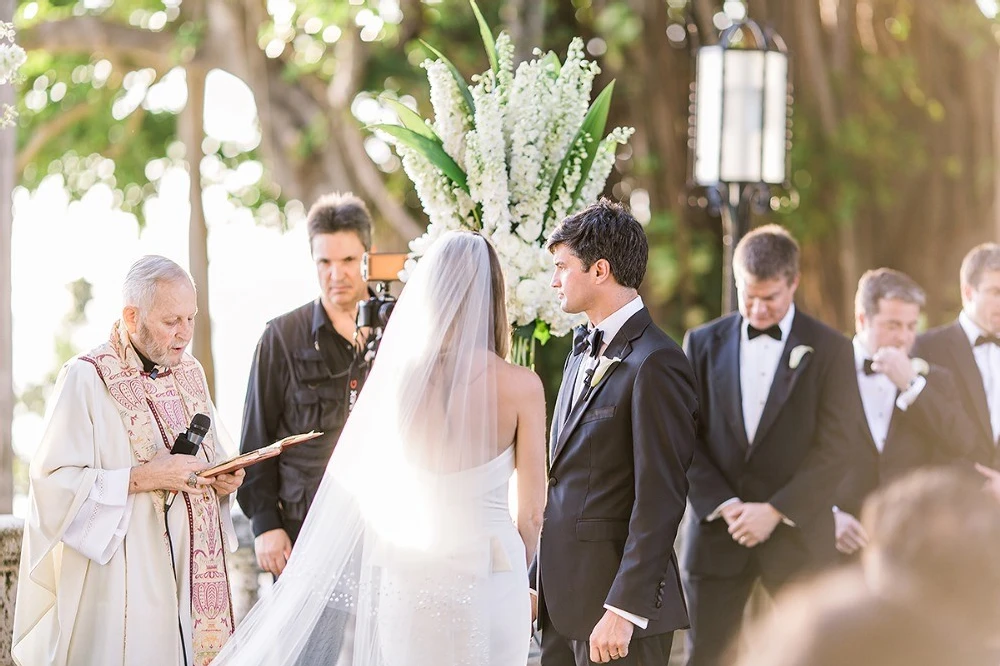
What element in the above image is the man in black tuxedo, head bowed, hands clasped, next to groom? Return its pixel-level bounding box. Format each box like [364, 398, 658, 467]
[682, 225, 858, 666]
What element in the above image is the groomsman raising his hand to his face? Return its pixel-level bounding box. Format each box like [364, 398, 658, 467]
[833, 268, 974, 555]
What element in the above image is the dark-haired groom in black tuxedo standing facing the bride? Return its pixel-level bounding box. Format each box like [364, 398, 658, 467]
[531, 199, 698, 666]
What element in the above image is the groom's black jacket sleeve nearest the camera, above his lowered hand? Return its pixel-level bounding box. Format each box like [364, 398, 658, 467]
[605, 347, 698, 619]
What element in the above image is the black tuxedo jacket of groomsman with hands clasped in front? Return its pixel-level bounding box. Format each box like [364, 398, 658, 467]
[682, 310, 858, 581]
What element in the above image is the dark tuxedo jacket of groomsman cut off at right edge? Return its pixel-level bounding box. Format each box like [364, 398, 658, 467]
[913, 321, 1000, 469]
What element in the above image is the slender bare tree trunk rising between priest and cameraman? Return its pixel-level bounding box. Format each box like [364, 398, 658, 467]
[178, 63, 215, 395]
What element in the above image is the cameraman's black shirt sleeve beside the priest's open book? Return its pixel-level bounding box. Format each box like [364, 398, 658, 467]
[236, 325, 289, 536]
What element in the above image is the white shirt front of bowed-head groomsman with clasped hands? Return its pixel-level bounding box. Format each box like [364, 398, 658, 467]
[740, 304, 795, 444]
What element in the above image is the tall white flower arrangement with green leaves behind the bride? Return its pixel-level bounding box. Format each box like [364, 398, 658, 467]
[374, 0, 634, 365]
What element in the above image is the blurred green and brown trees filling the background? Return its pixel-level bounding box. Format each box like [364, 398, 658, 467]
[15, 0, 1000, 398]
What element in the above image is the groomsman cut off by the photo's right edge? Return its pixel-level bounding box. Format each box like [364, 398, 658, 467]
[916, 243, 1000, 469]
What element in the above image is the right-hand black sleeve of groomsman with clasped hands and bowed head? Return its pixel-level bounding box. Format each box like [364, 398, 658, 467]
[769, 336, 863, 525]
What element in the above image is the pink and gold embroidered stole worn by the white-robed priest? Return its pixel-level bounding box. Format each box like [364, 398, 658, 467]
[81, 320, 233, 666]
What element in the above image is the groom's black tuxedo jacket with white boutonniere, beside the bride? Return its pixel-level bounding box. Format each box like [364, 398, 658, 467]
[536, 309, 698, 640]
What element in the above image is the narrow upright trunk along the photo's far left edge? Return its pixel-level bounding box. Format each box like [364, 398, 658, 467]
[0, 0, 17, 513]
